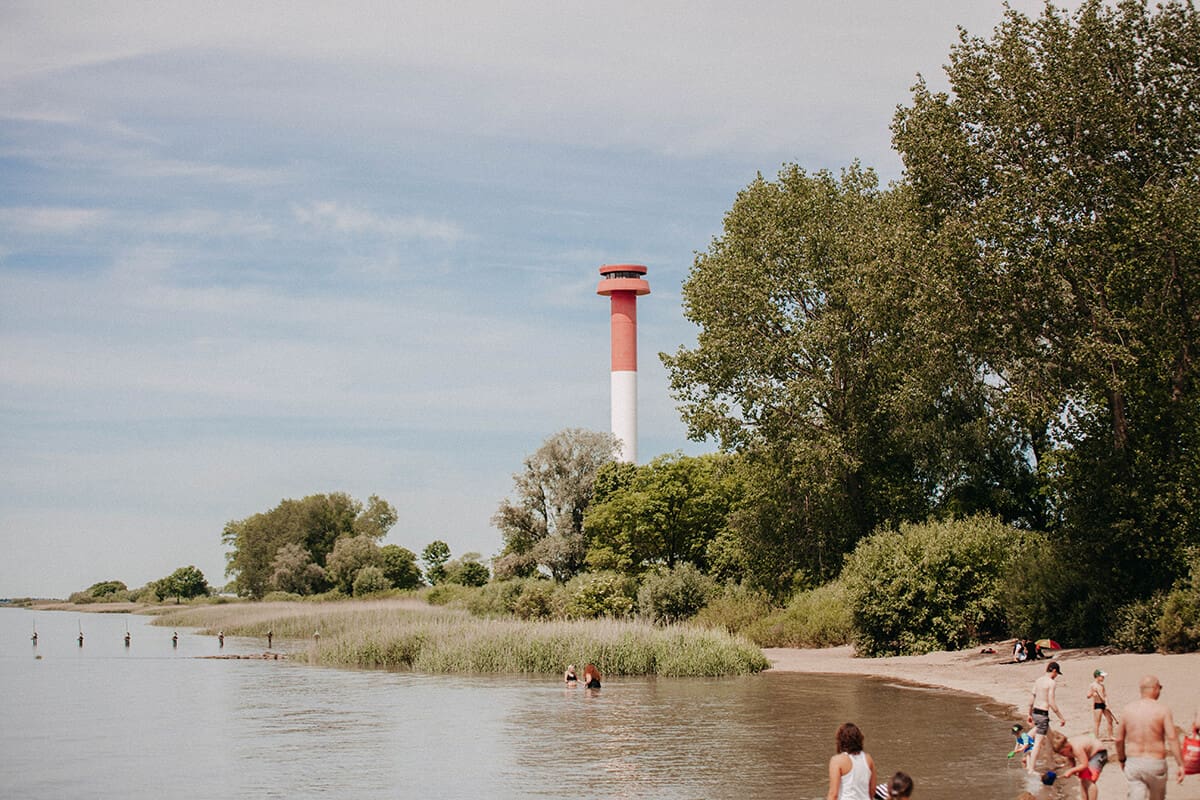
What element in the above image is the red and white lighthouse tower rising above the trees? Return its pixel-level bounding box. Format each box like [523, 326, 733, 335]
[596, 264, 650, 464]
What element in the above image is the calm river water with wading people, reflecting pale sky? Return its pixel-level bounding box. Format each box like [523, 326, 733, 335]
[0, 609, 1022, 800]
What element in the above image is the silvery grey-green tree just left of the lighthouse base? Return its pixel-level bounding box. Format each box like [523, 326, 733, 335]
[492, 428, 617, 582]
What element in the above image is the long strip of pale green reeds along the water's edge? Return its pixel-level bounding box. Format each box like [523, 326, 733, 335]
[154, 600, 768, 676]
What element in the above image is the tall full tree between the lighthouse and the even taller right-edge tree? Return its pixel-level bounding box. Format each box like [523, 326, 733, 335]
[662, 164, 1021, 593]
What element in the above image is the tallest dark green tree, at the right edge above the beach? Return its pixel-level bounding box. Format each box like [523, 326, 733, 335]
[894, 0, 1200, 623]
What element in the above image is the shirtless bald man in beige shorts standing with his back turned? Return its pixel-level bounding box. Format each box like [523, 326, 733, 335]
[1116, 675, 1183, 800]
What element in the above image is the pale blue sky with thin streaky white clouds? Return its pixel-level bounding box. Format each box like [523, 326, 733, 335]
[0, 0, 1070, 597]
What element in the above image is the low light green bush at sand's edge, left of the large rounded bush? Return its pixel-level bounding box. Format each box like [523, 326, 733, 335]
[742, 581, 854, 648]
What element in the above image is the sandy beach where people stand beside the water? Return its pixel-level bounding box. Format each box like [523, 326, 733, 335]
[763, 643, 1200, 800]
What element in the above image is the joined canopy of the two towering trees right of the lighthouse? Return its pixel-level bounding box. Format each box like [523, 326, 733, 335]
[664, 0, 1200, 640]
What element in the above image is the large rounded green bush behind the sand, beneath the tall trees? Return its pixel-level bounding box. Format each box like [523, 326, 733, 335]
[841, 517, 1042, 656]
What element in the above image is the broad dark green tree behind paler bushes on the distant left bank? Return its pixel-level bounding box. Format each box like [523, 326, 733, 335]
[221, 492, 396, 599]
